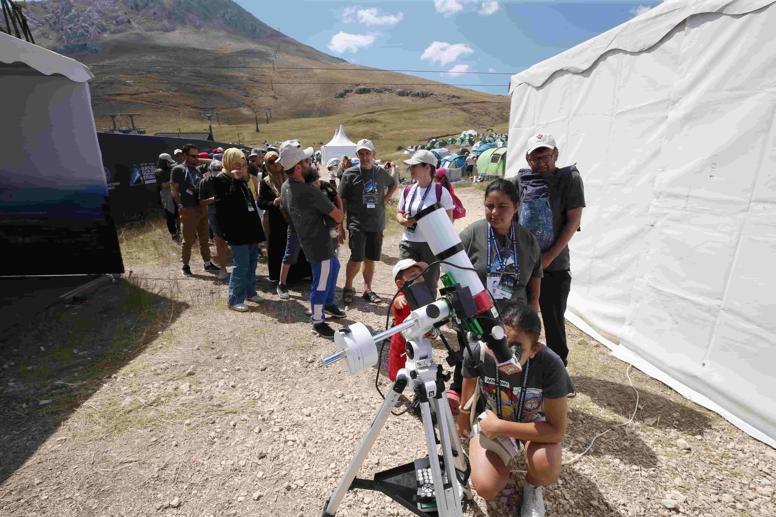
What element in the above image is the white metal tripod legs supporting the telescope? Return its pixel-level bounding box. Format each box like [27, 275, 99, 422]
[322, 334, 469, 517]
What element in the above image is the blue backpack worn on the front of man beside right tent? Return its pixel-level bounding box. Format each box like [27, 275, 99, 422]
[517, 165, 576, 253]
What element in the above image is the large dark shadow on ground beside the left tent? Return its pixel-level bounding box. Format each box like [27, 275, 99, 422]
[0, 280, 187, 483]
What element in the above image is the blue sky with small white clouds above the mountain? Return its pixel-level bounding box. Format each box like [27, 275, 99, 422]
[236, 0, 659, 94]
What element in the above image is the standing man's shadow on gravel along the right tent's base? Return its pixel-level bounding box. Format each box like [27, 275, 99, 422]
[574, 376, 711, 435]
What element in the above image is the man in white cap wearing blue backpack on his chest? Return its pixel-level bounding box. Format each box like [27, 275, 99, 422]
[515, 133, 585, 364]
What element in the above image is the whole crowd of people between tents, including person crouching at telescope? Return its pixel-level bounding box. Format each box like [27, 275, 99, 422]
[157, 134, 585, 516]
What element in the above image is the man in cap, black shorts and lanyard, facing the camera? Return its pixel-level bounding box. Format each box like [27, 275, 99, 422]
[339, 138, 397, 305]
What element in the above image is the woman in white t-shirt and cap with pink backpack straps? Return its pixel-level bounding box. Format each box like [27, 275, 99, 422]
[396, 149, 455, 292]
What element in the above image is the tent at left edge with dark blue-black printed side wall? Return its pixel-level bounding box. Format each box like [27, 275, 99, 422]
[0, 32, 122, 275]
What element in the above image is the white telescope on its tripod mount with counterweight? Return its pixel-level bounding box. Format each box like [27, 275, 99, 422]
[322, 204, 522, 517]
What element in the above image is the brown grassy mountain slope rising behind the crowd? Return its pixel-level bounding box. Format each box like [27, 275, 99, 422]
[25, 0, 508, 145]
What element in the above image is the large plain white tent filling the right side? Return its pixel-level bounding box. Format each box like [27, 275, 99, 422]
[507, 0, 776, 446]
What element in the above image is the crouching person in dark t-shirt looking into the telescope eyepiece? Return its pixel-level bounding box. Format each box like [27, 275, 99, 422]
[456, 302, 574, 517]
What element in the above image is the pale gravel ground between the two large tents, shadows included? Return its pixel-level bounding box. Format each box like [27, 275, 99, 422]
[0, 183, 776, 517]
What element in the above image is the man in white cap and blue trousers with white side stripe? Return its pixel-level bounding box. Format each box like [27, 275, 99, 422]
[280, 140, 345, 339]
